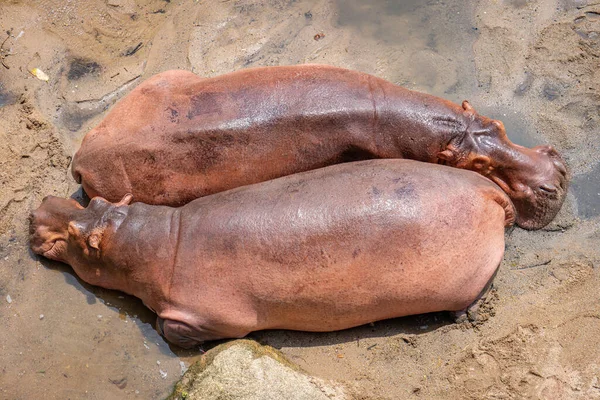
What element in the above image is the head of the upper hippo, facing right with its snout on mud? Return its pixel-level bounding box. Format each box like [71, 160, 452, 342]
[438, 101, 568, 229]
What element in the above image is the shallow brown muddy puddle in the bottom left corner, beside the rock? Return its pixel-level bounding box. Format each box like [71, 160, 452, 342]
[0, 247, 193, 399]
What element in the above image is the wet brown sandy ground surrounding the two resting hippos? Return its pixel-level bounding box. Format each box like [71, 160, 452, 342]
[0, 0, 600, 399]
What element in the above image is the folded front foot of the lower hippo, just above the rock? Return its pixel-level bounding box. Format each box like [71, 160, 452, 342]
[156, 317, 250, 349]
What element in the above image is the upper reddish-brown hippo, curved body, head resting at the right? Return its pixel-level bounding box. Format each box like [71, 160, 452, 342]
[72, 65, 567, 229]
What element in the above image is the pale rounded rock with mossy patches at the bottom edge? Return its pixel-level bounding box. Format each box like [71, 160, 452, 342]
[168, 340, 347, 400]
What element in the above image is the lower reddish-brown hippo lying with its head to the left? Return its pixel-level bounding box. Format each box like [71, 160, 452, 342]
[31, 159, 515, 348]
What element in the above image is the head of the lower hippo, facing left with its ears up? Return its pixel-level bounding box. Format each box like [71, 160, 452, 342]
[29, 194, 132, 287]
